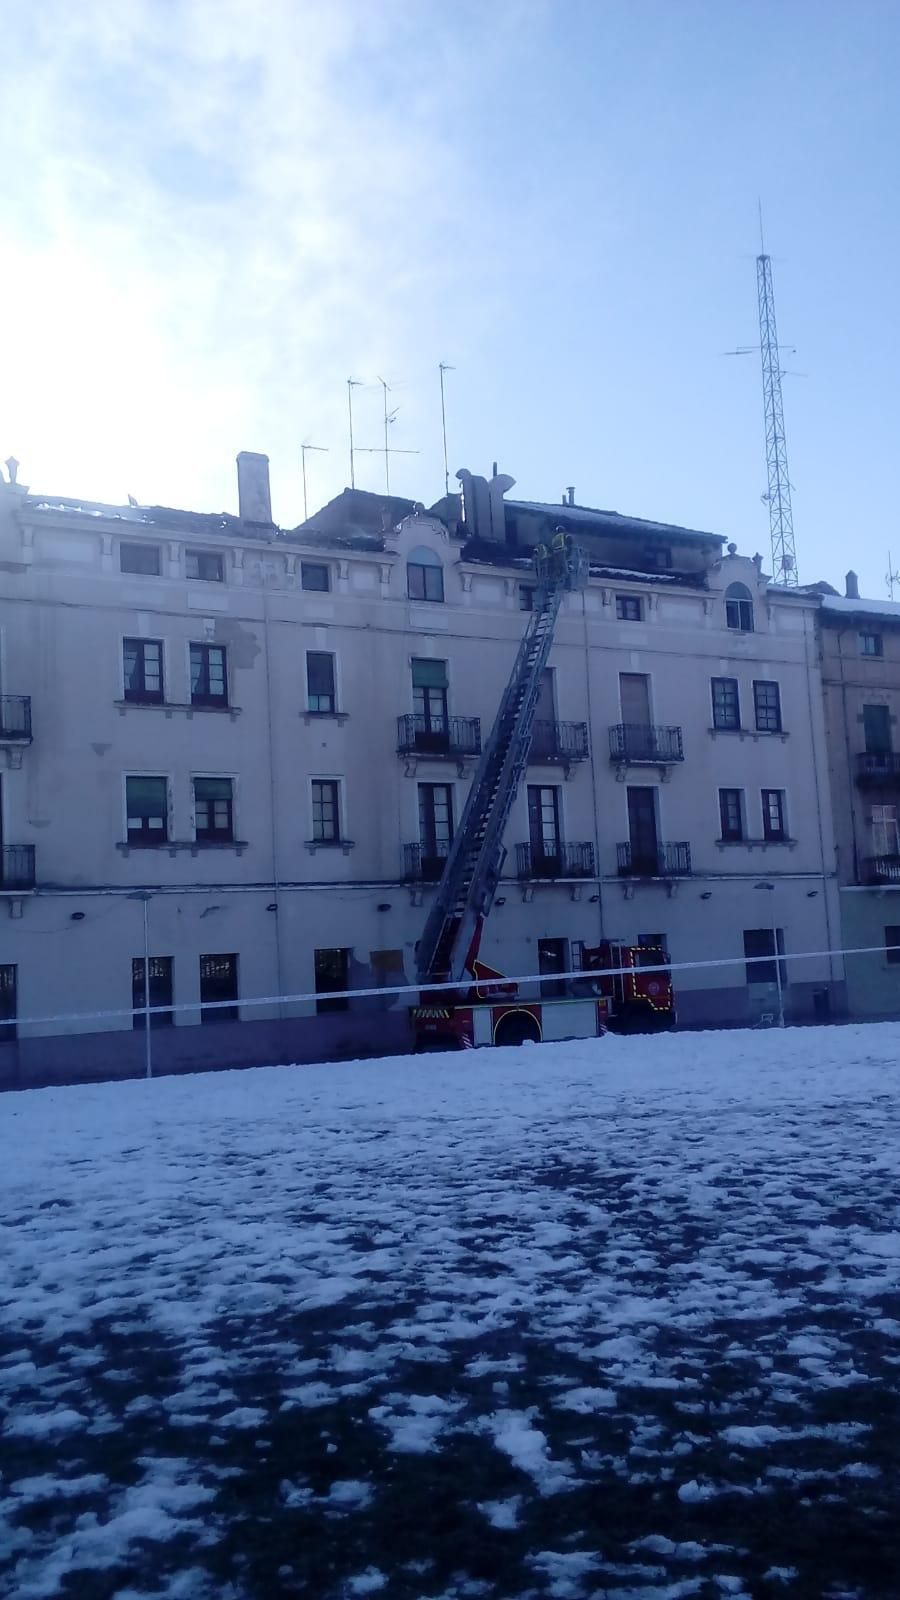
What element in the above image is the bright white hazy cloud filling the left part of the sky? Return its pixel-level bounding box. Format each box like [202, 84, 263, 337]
[0, 0, 540, 520]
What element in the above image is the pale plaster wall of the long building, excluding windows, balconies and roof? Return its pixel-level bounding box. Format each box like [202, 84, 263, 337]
[0, 470, 842, 1061]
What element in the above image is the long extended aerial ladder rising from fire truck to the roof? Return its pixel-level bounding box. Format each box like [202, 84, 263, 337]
[416, 531, 588, 989]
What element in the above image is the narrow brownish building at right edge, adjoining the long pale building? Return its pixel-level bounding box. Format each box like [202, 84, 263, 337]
[820, 585, 900, 1018]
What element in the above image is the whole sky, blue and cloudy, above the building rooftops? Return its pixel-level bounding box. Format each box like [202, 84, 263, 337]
[0, 0, 900, 597]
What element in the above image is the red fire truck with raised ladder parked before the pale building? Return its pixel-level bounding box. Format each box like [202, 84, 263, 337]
[412, 531, 674, 1050]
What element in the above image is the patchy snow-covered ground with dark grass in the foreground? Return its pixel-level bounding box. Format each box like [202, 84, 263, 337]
[0, 1026, 900, 1600]
